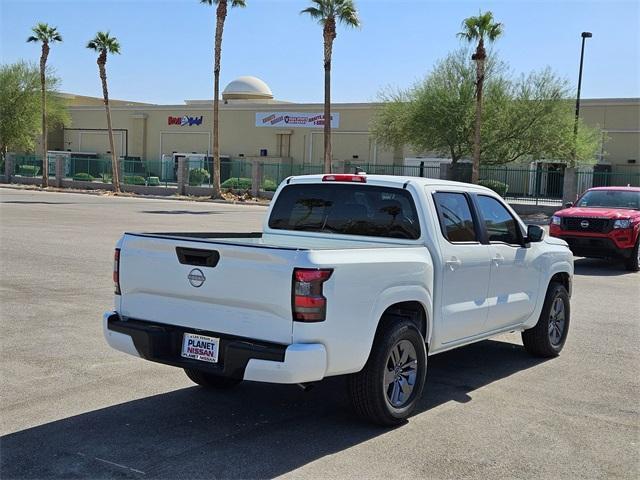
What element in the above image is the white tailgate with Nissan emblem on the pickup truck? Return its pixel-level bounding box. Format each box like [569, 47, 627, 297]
[120, 234, 299, 344]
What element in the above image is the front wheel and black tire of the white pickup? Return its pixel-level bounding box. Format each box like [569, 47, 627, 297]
[522, 282, 571, 358]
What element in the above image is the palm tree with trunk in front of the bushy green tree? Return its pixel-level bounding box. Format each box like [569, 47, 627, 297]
[458, 12, 503, 183]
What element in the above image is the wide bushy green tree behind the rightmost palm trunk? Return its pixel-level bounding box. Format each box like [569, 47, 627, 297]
[371, 50, 600, 172]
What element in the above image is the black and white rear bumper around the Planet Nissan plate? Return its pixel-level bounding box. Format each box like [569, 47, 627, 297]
[103, 312, 327, 383]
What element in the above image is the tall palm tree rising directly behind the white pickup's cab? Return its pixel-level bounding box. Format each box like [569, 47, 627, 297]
[300, 0, 360, 173]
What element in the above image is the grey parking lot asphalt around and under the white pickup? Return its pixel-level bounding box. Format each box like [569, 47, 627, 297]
[0, 188, 640, 479]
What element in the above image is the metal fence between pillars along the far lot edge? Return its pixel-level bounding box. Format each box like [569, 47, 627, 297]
[6, 155, 640, 205]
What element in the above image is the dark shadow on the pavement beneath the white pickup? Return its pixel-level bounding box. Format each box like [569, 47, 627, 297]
[0, 340, 540, 479]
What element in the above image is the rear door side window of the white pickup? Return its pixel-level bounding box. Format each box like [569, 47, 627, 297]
[433, 192, 478, 242]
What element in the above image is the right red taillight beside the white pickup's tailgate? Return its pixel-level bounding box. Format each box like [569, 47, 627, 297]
[291, 268, 333, 322]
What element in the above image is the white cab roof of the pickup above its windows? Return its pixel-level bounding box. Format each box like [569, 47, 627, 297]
[287, 173, 493, 193]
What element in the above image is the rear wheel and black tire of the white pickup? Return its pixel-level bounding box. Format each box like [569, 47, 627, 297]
[348, 318, 427, 426]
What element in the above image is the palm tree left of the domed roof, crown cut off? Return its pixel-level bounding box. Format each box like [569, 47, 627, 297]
[200, 0, 246, 198]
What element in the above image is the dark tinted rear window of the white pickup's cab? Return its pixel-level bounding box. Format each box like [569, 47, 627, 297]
[269, 184, 420, 240]
